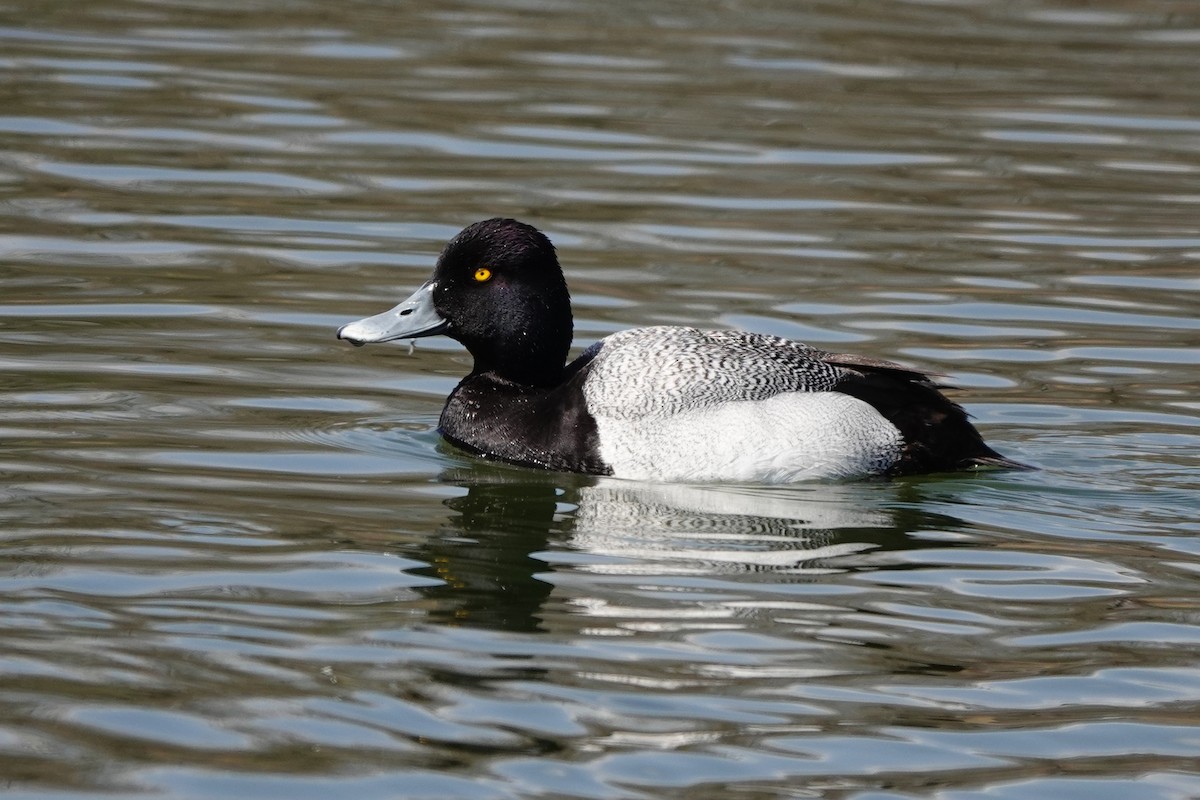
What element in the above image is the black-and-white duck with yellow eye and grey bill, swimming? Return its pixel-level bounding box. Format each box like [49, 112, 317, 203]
[337, 217, 1024, 483]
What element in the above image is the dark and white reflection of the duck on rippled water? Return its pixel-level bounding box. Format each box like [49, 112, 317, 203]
[419, 465, 955, 631]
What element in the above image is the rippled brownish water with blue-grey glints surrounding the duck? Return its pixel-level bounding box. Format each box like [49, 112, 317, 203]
[0, 0, 1200, 800]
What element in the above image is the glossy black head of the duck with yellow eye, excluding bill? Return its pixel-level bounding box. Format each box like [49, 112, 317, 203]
[433, 218, 572, 385]
